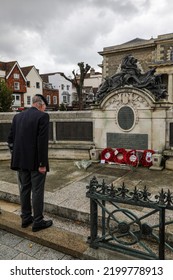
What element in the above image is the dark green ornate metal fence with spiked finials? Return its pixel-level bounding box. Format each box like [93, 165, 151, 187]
[86, 177, 173, 259]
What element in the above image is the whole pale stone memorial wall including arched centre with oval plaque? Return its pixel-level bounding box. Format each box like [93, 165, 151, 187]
[0, 92, 173, 160]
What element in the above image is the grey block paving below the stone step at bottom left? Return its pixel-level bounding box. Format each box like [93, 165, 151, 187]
[0, 229, 75, 260]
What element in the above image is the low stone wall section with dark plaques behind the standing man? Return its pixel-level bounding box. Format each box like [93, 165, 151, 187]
[0, 111, 95, 160]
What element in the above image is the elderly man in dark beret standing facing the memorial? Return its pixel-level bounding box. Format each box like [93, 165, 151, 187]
[8, 94, 53, 232]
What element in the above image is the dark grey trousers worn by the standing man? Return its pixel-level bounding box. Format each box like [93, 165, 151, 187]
[18, 170, 46, 223]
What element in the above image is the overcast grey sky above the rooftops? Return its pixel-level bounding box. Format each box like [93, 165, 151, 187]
[0, 0, 173, 75]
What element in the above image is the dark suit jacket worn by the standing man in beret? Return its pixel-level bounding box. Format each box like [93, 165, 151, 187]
[8, 107, 49, 171]
